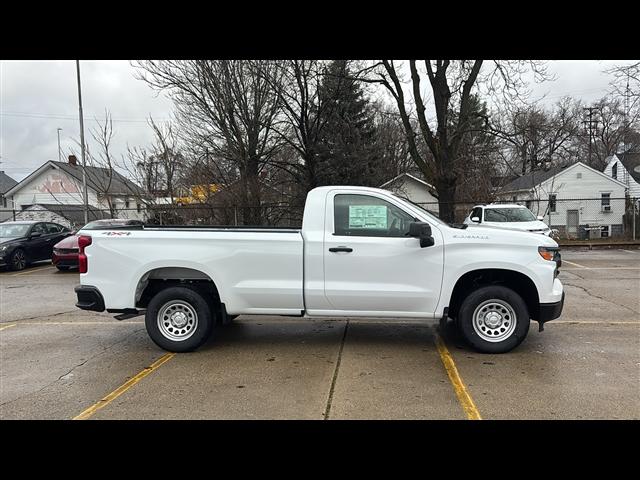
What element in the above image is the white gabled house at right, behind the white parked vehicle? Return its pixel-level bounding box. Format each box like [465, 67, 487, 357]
[499, 162, 626, 238]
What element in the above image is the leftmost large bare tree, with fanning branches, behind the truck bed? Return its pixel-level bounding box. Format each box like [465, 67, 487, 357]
[138, 60, 281, 224]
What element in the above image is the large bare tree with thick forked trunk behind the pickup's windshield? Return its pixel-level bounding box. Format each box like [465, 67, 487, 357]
[365, 60, 546, 222]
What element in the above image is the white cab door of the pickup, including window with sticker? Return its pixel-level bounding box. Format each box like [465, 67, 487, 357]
[324, 190, 444, 316]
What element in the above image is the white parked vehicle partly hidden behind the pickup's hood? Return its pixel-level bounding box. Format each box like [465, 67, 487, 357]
[463, 203, 551, 236]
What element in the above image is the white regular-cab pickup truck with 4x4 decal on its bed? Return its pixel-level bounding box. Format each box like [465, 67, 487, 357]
[75, 186, 564, 353]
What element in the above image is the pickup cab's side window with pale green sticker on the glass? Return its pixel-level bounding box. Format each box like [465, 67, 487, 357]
[333, 195, 415, 237]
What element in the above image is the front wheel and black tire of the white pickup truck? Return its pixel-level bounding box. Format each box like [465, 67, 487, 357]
[457, 285, 530, 353]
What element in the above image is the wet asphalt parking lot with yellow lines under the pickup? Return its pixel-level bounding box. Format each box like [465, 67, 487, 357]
[0, 249, 640, 419]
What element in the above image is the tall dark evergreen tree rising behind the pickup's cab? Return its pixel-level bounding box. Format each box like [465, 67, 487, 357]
[317, 60, 387, 186]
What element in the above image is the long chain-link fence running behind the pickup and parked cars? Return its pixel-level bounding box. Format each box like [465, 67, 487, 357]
[0, 194, 640, 240]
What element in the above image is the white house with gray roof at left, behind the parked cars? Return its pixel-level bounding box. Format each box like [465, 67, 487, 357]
[5, 156, 145, 225]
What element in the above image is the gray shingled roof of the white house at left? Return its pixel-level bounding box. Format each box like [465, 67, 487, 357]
[5, 160, 144, 195]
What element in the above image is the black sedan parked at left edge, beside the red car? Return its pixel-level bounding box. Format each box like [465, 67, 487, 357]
[0, 221, 72, 270]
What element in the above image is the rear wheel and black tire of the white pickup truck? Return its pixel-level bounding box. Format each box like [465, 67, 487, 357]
[145, 287, 215, 352]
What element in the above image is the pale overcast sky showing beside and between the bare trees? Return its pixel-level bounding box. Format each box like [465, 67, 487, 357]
[0, 60, 630, 180]
